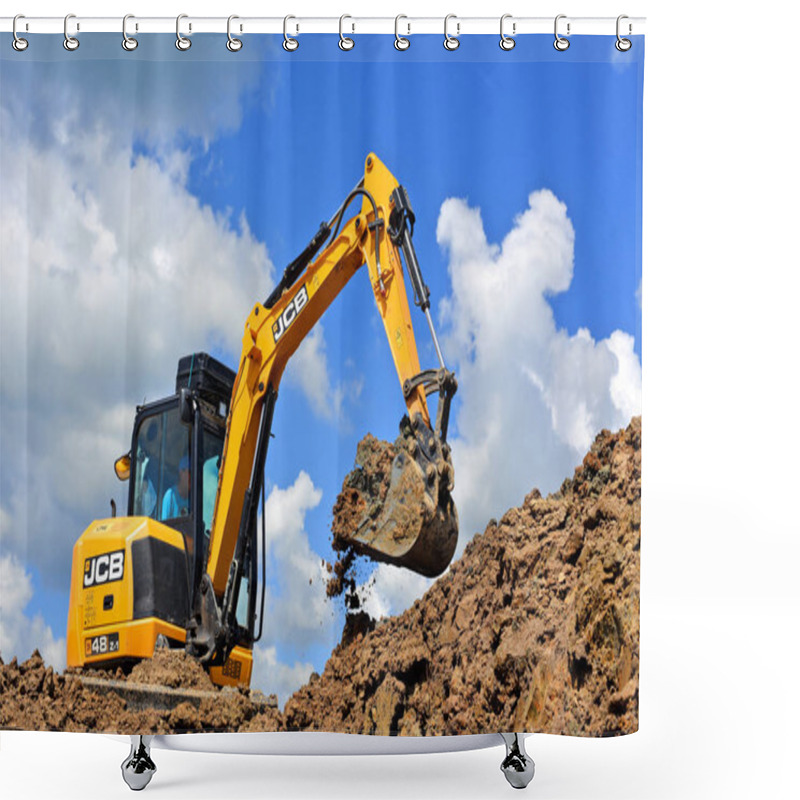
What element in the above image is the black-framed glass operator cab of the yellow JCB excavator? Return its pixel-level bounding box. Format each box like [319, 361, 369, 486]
[122, 353, 255, 639]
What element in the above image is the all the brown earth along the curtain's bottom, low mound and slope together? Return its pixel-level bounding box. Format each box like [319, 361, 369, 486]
[0, 418, 641, 736]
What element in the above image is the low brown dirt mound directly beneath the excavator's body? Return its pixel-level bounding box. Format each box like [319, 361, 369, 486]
[0, 649, 282, 734]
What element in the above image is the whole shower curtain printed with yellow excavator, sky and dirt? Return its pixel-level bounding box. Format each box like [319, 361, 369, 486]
[0, 29, 644, 736]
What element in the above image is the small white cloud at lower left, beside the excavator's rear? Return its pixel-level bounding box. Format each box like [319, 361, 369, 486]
[0, 552, 66, 670]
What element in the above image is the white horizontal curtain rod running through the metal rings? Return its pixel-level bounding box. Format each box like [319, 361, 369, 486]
[0, 15, 645, 36]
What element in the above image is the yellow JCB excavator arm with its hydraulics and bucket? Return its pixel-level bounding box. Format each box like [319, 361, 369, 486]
[187, 154, 458, 663]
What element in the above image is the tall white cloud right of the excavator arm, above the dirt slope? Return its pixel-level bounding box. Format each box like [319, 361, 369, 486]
[437, 190, 641, 548]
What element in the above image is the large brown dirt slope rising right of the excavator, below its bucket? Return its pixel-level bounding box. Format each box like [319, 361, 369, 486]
[284, 418, 641, 736]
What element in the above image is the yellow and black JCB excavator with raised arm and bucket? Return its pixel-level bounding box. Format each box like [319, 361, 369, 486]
[67, 154, 458, 686]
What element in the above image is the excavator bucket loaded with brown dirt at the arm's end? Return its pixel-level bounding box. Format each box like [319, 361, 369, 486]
[334, 416, 458, 578]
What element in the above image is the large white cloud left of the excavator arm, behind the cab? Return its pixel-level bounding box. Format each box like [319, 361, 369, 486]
[0, 109, 272, 577]
